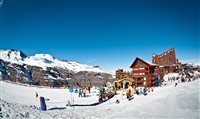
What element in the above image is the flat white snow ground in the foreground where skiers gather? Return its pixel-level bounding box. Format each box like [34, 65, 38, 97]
[0, 79, 200, 119]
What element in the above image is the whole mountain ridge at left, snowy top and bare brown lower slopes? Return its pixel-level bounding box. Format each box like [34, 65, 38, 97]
[0, 50, 113, 87]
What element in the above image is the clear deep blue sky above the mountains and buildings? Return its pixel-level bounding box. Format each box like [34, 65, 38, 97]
[0, 0, 200, 71]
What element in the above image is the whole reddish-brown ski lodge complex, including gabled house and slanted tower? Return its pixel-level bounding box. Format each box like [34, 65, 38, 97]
[114, 48, 181, 88]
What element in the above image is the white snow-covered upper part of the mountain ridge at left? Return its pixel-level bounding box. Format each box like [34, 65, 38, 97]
[0, 50, 107, 73]
